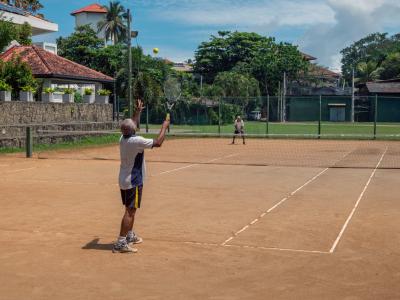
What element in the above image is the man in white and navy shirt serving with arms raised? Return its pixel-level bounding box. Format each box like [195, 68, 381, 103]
[113, 100, 169, 253]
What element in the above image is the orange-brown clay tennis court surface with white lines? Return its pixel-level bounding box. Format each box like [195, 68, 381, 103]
[0, 139, 400, 300]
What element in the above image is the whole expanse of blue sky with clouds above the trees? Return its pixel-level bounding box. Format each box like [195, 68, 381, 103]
[36, 0, 400, 71]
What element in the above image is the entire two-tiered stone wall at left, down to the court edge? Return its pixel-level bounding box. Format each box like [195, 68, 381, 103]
[0, 102, 118, 148]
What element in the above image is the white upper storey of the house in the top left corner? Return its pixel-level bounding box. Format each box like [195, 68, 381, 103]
[0, 2, 58, 36]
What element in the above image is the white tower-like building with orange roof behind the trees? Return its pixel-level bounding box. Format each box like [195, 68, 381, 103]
[71, 3, 107, 40]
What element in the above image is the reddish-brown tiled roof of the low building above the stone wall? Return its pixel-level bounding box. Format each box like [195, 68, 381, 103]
[0, 46, 114, 82]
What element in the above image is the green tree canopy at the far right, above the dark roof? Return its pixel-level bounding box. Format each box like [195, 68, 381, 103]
[341, 33, 400, 81]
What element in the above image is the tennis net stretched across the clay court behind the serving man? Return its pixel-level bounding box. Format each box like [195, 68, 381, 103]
[12, 129, 400, 169]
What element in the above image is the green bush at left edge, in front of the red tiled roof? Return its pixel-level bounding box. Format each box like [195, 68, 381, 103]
[0, 56, 38, 93]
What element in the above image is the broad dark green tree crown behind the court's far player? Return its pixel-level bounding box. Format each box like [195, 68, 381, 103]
[194, 31, 309, 94]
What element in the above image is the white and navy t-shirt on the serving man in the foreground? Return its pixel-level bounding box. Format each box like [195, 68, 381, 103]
[119, 135, 153, 190]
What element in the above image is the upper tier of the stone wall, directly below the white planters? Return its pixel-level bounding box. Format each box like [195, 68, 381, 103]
[0, 101, 113, 125]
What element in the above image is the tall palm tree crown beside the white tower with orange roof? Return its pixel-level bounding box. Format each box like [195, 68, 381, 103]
[97, 1, 126, 45]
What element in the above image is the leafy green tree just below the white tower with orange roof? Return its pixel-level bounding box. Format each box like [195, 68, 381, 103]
[57, 25, 104, 68]
